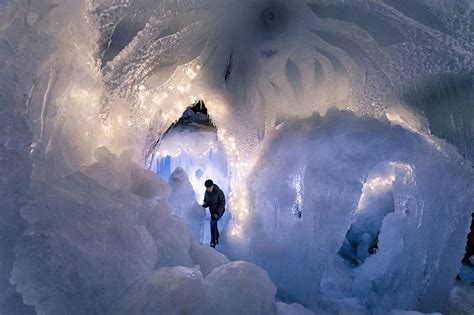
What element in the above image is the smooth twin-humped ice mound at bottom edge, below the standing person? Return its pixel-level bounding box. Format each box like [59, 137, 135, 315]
[119, 261, 282, 315]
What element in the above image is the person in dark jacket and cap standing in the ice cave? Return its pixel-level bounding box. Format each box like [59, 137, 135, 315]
[202, 179, 225, 248]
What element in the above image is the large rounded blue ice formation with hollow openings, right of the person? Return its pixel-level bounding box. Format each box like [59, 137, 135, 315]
[243, 111, 472, 314]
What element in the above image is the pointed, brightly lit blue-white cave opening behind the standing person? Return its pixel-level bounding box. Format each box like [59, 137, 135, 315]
[153, 100, 230, 244]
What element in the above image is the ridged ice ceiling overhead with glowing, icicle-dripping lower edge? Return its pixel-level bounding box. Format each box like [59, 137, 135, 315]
[92, 0, 472, 235]
